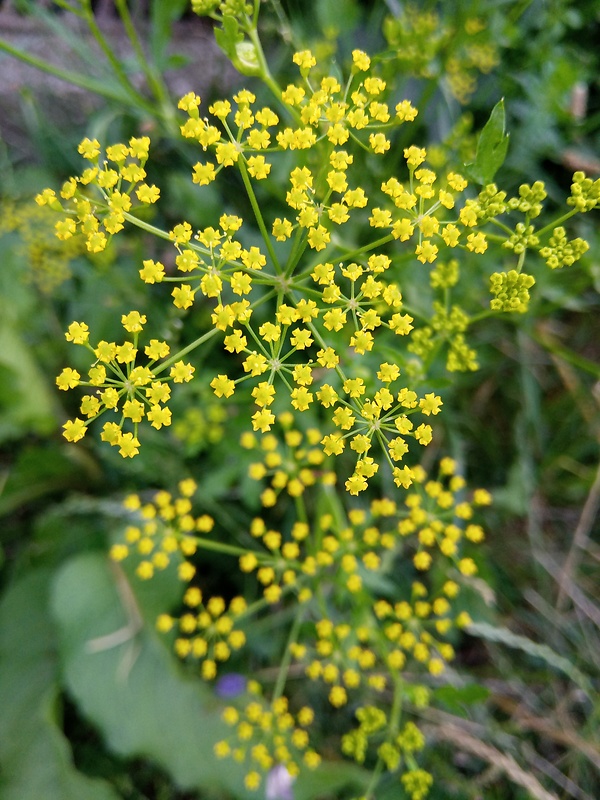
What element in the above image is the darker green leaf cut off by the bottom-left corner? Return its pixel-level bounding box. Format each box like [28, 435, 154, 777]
[0, 570, 119, 800]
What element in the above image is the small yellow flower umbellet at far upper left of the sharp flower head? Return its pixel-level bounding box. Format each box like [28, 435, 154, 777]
[35, 136, 160, 253]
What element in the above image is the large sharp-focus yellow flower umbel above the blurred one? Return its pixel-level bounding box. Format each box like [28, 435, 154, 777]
[44, 45, 596, 482]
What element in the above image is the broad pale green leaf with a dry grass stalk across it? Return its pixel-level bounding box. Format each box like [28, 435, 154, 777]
[52, 553, 252, 800]
